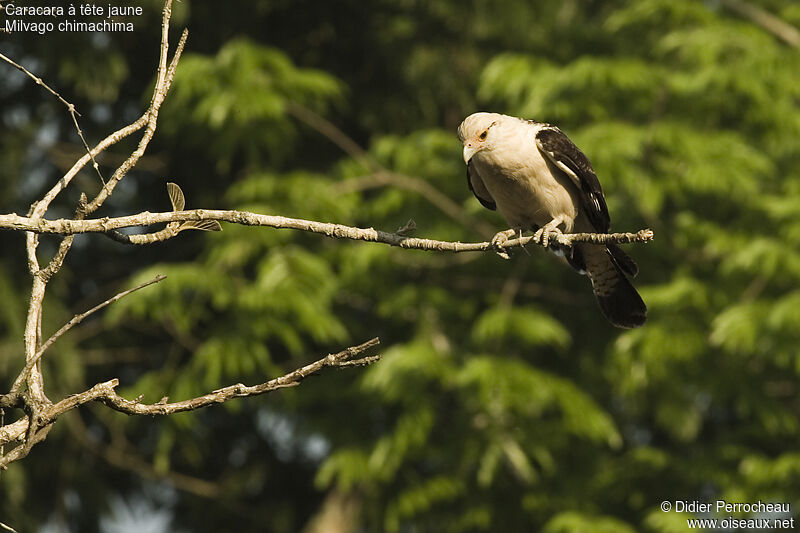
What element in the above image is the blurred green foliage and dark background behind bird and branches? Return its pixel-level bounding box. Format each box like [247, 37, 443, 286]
[0, 0, 800, 533]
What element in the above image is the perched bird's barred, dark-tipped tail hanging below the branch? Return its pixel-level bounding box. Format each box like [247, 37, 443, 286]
[583, 245, 647, 328]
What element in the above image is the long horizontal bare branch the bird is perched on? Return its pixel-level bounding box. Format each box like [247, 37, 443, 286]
[0, 209, 653, 252]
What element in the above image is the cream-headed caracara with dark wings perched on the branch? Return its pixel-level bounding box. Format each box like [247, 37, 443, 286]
[458, 112, 647, 328]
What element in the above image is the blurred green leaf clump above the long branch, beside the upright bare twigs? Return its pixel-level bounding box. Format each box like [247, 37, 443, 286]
[163, 38, 342, 170]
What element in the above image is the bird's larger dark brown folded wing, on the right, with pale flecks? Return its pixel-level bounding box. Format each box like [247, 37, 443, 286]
[536, 124, 611, 233]
